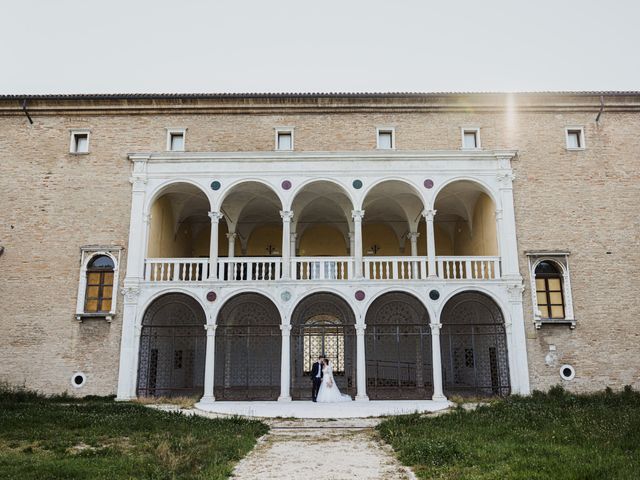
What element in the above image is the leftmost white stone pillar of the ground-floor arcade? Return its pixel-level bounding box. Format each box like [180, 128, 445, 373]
[116, 283, 140, 400]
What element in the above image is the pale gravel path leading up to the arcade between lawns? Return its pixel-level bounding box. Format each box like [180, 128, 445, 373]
[232, 419, 415, 480]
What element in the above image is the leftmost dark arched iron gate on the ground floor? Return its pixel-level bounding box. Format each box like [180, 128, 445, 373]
[137, 293, 207, 397]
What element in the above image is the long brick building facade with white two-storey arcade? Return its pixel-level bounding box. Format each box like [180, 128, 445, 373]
[0, 92, 640, 400]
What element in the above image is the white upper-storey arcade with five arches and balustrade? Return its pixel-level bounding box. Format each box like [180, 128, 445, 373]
[128, 151, 518, 284]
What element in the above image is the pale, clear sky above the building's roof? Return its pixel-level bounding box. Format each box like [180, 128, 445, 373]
[0, 0, 640, 94]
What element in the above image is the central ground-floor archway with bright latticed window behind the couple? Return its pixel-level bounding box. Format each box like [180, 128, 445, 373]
[291, 293, 356, 400]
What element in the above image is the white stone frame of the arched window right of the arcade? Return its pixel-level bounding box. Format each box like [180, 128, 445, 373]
[526, 251, 576, 330]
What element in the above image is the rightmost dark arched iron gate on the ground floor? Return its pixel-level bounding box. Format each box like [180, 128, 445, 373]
[440, 292, 511, 397]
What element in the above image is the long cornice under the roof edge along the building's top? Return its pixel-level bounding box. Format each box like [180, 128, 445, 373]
[0, 91, 640, 115]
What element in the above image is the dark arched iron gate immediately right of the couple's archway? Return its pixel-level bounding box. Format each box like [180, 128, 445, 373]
[365, 292, 433, 400]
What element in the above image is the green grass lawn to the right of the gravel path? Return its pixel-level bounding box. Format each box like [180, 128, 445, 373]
[378, 387, 640, 480]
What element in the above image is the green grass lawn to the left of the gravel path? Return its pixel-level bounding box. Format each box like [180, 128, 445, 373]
[0, 390, 268, 480]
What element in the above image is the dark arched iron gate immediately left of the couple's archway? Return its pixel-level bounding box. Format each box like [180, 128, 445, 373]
[214, 293, 282, 400]
